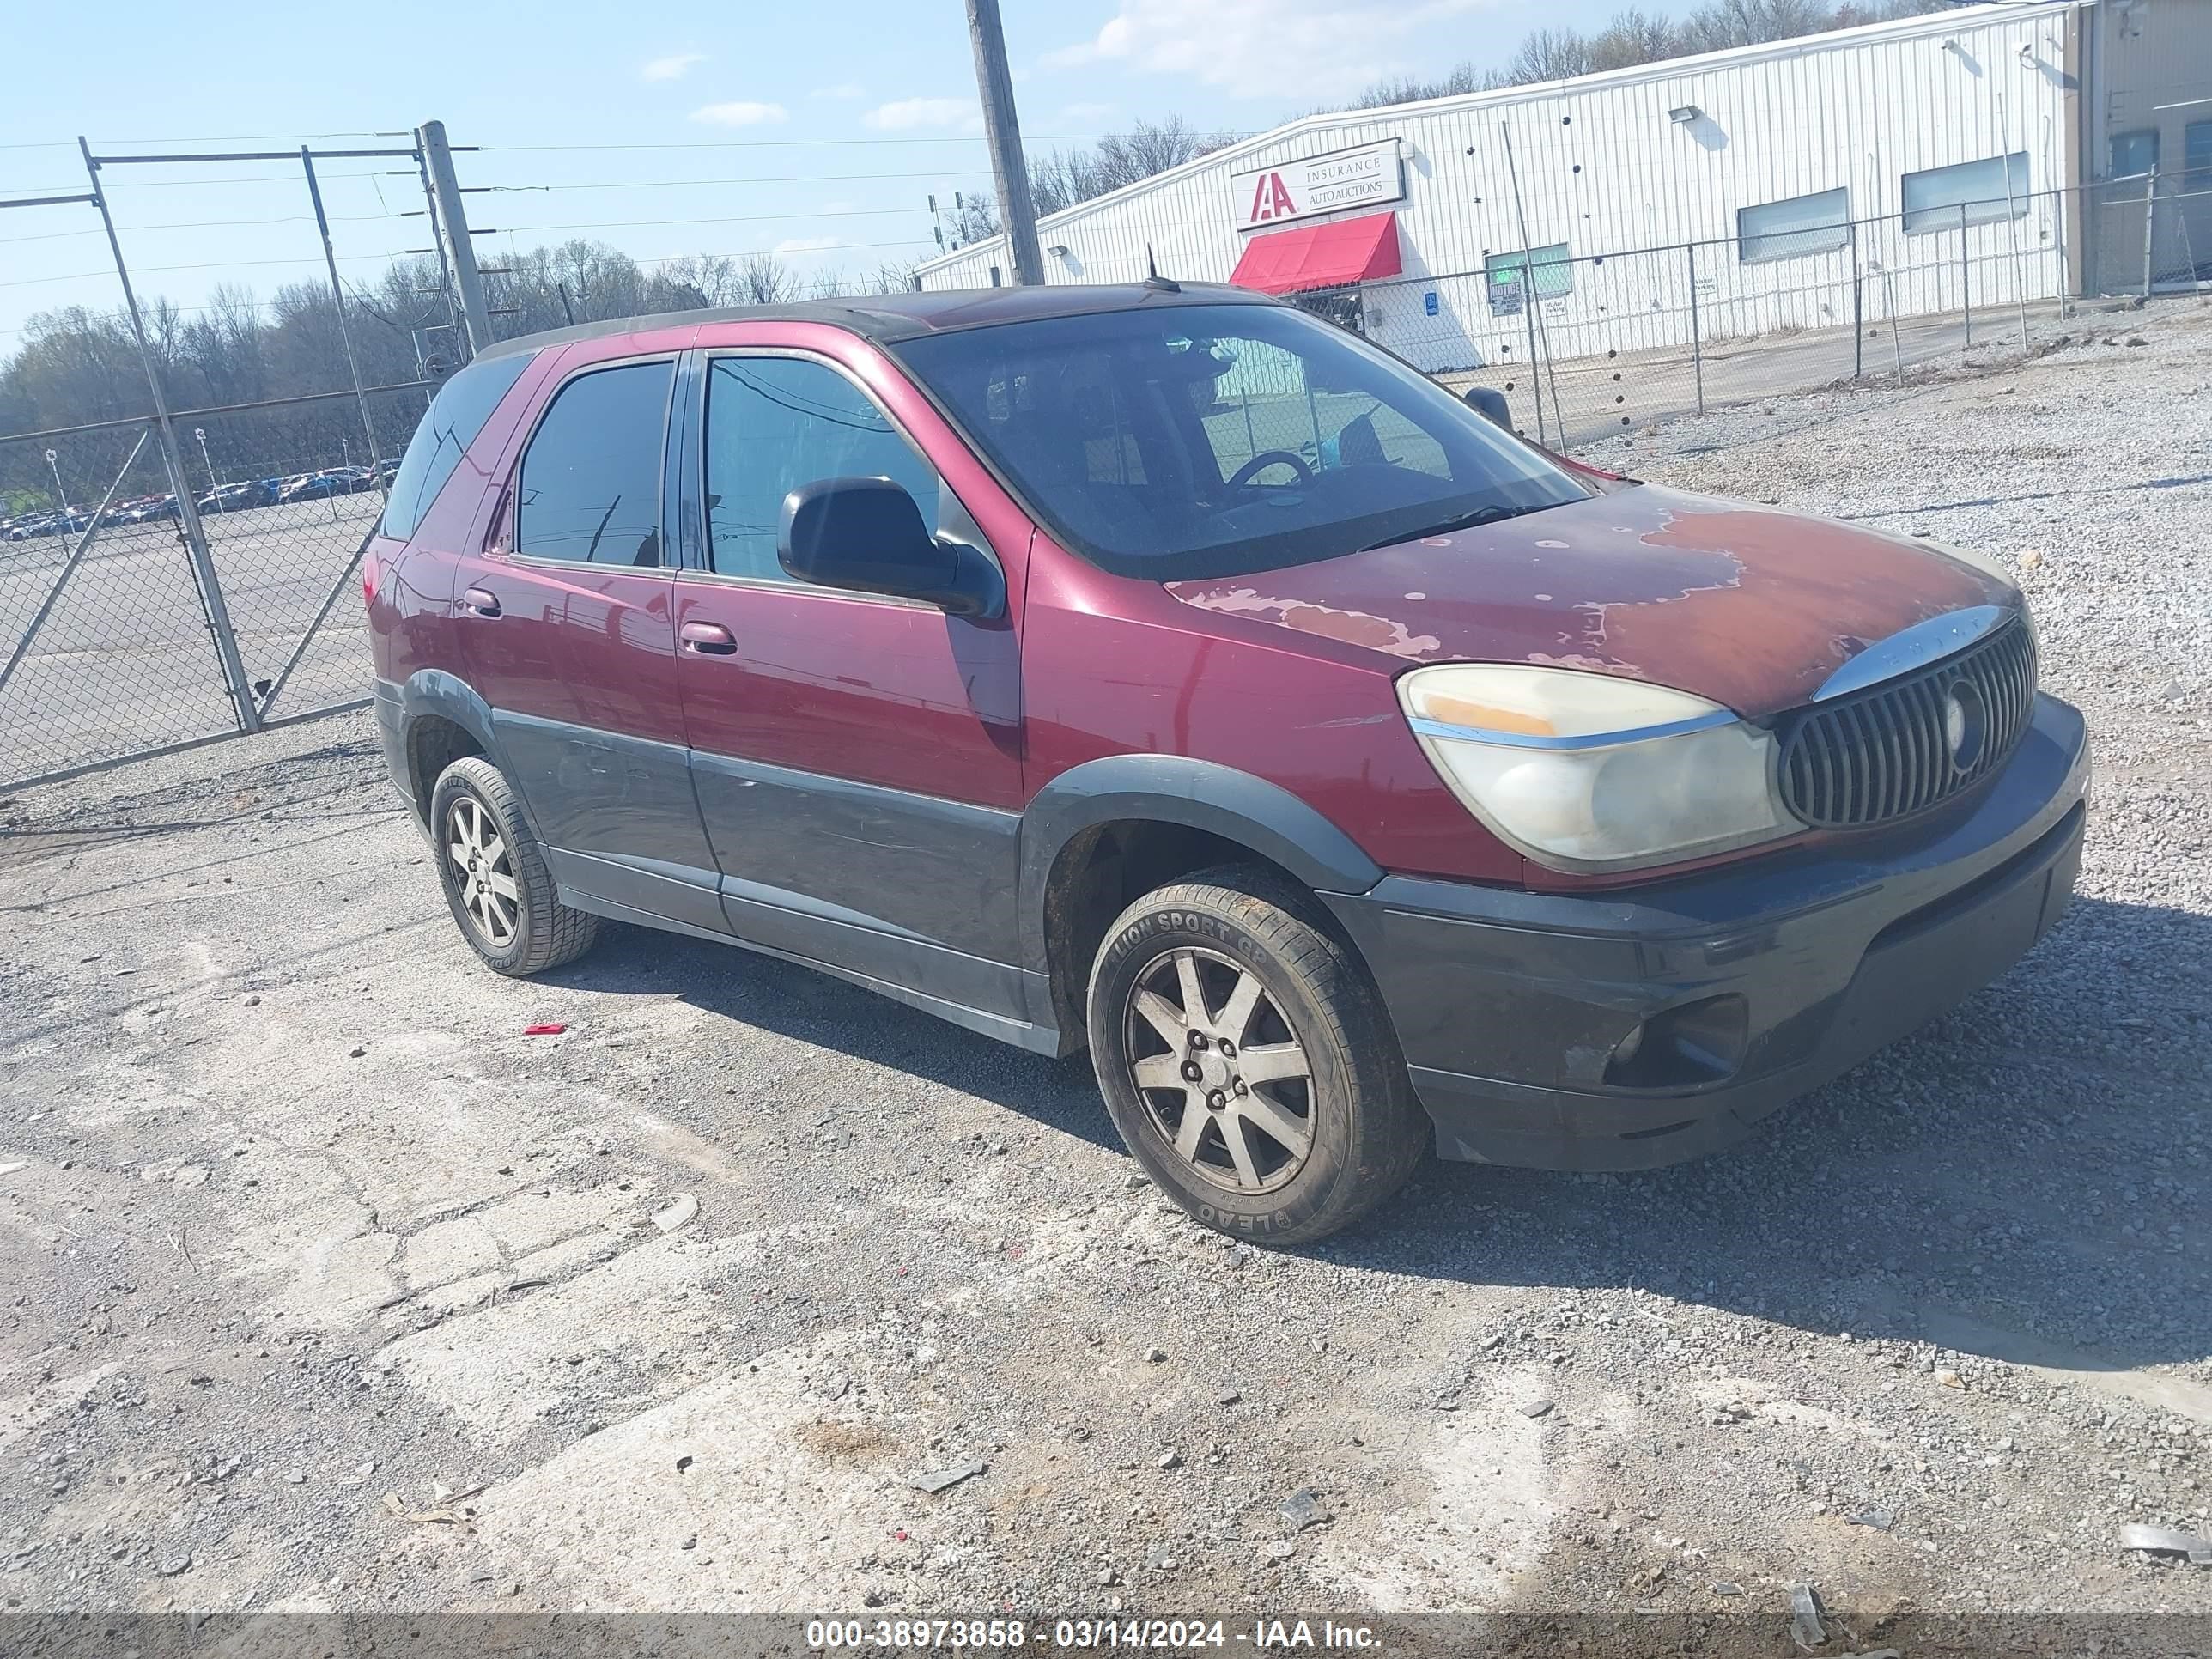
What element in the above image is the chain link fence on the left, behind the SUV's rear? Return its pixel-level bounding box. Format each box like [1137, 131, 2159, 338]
[0, 383, 434, 781]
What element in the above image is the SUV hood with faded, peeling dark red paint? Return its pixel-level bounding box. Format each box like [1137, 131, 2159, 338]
[1166, 484, 2020, 717]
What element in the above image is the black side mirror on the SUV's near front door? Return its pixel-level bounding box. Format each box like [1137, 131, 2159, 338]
[776, 477, 1006, 617]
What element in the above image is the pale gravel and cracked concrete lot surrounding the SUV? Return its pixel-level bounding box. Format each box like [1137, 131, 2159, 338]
[0, 307, 2212, 1652]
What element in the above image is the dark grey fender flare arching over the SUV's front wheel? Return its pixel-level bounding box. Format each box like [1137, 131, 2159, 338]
[1018, 754, 1382, 973]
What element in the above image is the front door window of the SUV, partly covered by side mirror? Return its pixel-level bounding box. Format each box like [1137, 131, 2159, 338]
[706, 356, 938, 581]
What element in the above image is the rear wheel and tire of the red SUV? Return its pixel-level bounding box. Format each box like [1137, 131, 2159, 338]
[429, 754, 599, 978]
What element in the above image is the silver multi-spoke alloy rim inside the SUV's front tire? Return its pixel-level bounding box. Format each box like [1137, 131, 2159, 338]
[1124, 947, 1316, 1197]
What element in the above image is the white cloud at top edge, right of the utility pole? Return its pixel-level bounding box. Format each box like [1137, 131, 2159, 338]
[1044, 0, 1500, 100]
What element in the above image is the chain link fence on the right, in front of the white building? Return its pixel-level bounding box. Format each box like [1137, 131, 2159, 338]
[1303, 175, 2212, 452]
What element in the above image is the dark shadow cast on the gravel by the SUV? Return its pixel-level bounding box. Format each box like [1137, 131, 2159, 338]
[549, 898, 2212, 1402]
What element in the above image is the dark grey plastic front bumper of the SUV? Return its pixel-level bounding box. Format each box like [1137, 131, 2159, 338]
[1325, 696, 2090, 1170]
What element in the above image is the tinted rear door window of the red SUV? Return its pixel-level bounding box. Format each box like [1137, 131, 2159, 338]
[515, 362, 675, 564]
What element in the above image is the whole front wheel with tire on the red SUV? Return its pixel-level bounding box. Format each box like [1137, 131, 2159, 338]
[1086, 867, 1431, 1245]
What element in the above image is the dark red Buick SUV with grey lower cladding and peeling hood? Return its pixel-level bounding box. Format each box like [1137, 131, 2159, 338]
[365, 281, 2090, 1243]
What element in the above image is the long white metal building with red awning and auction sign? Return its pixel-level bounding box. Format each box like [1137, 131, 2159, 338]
[918, 0, 2212, 369]
